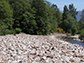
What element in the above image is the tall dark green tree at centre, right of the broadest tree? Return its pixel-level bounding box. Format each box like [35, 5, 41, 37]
[32, 0, 49, 35]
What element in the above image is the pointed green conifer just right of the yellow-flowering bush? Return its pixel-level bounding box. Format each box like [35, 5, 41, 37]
[61, 6, 77, 35]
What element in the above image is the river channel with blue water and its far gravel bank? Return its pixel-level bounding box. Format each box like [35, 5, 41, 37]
[52, 33, 84, 46]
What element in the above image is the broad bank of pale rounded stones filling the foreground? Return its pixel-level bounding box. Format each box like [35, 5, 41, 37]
[0, 33, 84, 63]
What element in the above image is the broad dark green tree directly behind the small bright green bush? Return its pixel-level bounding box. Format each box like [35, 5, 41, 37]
[9, 0, 37, 34]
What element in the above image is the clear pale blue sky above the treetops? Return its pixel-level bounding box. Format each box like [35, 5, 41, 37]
[47, 0, 84, 11]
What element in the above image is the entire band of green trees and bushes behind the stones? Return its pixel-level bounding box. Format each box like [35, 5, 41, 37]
[0, 0, 84, 37]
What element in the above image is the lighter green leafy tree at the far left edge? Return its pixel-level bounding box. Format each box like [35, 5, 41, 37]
[0, 0, 13, 30]
